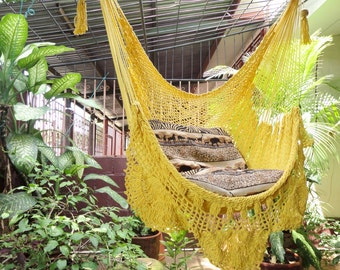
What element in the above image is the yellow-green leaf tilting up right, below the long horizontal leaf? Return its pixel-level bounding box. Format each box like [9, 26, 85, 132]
[44, 73, 81, 99]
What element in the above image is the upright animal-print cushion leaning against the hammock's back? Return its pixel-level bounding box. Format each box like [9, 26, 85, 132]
[150, 120, 246, 172]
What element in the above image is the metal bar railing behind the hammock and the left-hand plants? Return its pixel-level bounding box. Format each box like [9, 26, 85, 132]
[35, 79, 225, 156]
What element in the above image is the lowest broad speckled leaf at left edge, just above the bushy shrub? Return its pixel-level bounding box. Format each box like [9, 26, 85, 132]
[0, 192, 37, 218]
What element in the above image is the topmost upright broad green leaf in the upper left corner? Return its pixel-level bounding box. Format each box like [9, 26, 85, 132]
[0, 13, 28, 62]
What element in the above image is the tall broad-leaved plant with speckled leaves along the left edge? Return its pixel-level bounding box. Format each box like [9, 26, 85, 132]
[0, 14, 99, 202]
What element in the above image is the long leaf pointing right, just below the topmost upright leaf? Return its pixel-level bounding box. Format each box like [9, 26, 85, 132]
[18, 45, 74, 69]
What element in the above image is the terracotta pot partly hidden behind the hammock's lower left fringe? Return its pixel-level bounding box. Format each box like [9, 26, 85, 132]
[132, 231, 162, 260]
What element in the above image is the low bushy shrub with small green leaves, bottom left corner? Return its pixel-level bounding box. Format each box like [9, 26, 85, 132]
[0, 165, 144, 269]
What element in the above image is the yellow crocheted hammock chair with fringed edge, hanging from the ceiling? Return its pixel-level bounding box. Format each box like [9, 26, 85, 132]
[101, 0, 310, 270]
